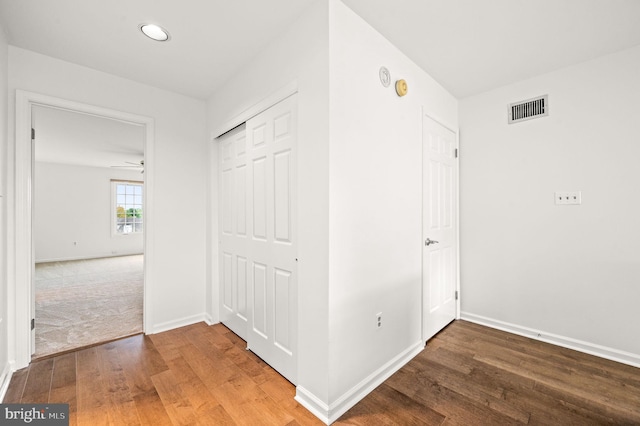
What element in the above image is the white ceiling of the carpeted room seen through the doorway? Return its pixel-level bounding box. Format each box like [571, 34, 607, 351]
[32, 106, 145, 170]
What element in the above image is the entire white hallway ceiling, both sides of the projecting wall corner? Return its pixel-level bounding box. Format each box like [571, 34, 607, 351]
[0, 0, 640, 99]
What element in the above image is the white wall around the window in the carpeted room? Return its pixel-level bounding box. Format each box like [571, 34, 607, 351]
[33, 162, 144, 262]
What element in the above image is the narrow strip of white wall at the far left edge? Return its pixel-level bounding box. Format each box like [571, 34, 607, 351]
[0, 20, 10, 401]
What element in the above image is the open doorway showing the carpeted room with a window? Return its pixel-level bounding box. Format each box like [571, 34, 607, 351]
[31, 105, 144, 359]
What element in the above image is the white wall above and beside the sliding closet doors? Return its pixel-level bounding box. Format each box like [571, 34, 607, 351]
[208, 1, 329, 401]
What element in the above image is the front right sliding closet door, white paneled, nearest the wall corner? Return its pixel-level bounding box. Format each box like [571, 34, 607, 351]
[246, 95, 297, 384]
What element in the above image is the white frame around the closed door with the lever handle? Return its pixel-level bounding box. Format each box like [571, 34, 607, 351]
[420, 110, 462, 342]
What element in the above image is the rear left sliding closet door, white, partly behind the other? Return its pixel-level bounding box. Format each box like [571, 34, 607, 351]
[218, 125, 248, 340]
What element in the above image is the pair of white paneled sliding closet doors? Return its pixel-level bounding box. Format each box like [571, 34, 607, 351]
[219, 95, 297, 384]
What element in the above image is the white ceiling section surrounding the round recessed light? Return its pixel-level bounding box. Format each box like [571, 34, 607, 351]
[0, 0, 314, 99]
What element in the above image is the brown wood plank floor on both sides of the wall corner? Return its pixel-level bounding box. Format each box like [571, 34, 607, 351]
[4, 321, 640, 426]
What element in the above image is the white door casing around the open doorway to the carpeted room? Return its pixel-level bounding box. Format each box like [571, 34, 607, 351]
[8, 90, 154, 369]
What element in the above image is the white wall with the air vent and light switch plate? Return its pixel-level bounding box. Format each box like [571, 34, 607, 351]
[460, 47, 640, 365]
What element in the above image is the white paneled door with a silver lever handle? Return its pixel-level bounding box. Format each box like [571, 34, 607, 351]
[422, 115, 458, 341]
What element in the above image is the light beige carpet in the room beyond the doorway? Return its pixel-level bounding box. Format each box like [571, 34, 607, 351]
[34, 255, 143, 357]
